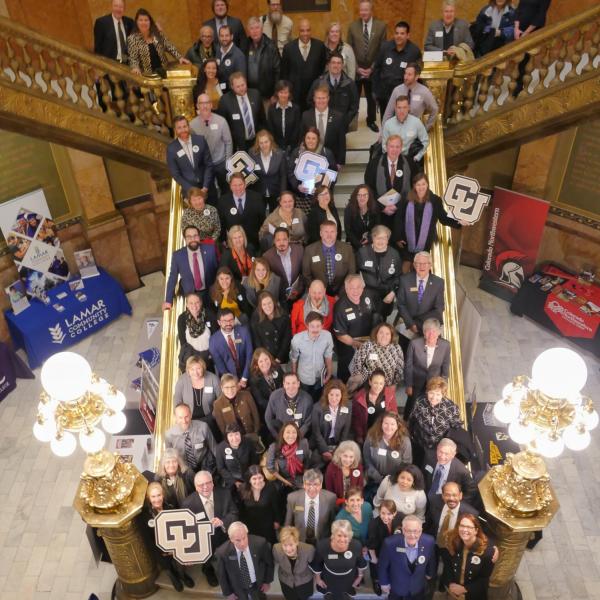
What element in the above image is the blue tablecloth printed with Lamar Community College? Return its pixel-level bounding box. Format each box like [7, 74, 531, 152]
[5, 269, 131, 369]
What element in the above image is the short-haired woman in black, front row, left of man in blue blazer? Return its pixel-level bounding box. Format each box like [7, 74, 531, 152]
[310, 519, 367, 600]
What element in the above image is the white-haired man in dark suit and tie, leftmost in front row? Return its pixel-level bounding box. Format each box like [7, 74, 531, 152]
[215, 521, 275, 600]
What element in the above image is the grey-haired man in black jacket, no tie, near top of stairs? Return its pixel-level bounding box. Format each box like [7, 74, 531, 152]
[242, 17, 281, 110]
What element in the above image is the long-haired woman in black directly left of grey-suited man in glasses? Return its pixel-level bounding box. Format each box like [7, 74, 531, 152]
[240, 465, 282, 544]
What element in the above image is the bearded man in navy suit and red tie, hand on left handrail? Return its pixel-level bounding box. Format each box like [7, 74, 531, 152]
[163, 225, 218, 310]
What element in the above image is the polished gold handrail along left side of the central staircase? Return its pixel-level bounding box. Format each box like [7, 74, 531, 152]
[154, 180, 185, 471]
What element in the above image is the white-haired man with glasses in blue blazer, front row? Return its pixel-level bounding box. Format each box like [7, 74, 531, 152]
[379, 515, 437, 600]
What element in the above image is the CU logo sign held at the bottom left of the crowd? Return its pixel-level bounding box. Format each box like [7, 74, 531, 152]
[154, 508, 213, 565]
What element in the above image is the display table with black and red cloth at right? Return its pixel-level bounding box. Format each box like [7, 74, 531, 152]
[510, 263, 600, 356]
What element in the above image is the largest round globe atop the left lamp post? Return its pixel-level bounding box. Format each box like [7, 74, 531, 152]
[41, 352, 92, 402]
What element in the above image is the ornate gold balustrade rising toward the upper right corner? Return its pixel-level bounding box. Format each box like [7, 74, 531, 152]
[444, 5, 600, 164]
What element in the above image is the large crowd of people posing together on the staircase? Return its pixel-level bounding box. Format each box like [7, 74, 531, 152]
[90, 0, 548, 600]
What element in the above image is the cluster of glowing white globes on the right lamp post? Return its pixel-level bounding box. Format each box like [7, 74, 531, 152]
[494, 348, 598, 458]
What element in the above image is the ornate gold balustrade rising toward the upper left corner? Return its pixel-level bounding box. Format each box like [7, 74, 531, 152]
[0, 17, 194, 174]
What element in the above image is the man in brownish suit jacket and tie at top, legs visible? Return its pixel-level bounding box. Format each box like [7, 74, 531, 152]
[346, 0, 387, 133]
